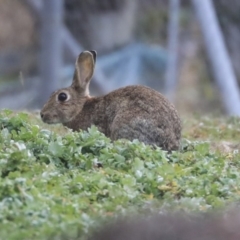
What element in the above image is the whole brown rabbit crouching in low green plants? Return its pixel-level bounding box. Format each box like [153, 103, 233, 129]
[41, 51, 181, 151]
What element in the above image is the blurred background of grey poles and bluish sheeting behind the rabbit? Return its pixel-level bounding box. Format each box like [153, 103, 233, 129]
[0, 0, 240, 115]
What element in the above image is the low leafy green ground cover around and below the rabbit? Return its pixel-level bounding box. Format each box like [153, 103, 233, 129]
[0, 110, 240, 240]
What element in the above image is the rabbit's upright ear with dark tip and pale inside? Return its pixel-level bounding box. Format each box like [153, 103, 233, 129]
[72, 51, 97, 95]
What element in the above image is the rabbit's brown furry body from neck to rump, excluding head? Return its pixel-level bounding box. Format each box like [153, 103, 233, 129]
[65, 86, 181, 150]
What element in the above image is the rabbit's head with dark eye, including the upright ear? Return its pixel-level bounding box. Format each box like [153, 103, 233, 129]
[40, 51, 97, 124]
